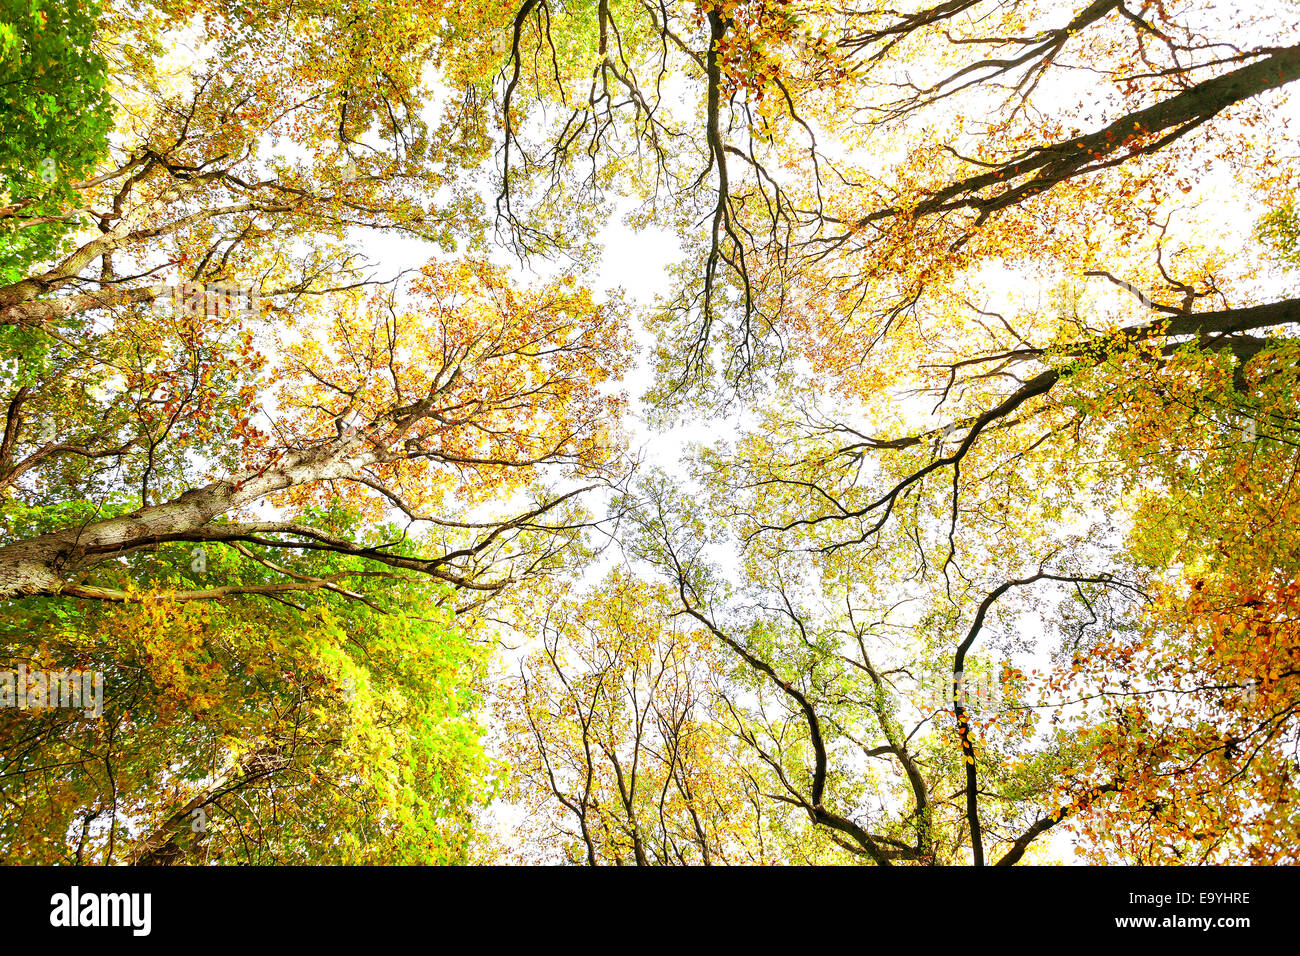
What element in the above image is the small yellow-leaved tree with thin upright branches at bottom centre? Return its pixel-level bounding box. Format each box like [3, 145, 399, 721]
[498, 572, 827, 866]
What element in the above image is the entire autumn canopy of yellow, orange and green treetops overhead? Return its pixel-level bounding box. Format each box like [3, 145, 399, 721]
[0, 0, 1300, 865]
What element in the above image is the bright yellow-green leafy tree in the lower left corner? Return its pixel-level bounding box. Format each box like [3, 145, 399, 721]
[0, 546, 490, 865]
